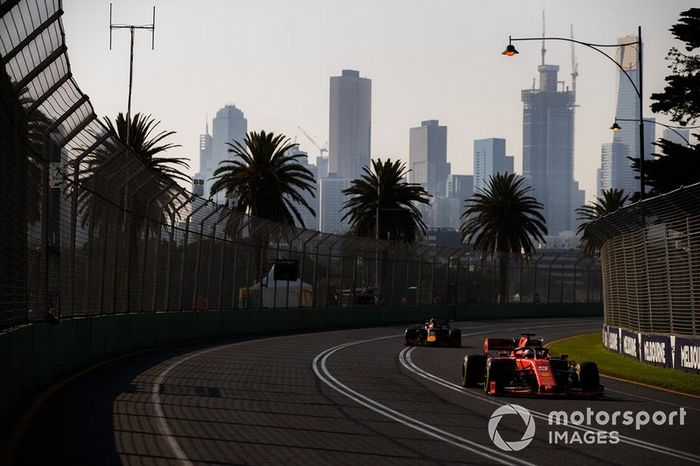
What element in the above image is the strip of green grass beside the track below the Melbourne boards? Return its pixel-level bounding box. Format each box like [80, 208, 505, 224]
[550, 332, 700, 396]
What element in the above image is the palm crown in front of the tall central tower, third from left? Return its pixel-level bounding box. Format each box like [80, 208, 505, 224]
[342, 159, 430, 243]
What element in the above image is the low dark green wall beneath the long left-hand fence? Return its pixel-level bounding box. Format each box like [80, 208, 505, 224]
[0, 304, 602, 432]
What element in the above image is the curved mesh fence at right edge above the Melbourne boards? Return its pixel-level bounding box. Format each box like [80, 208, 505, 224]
[590, 183, 700, 337]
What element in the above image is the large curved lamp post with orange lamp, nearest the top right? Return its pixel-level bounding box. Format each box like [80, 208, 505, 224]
[502, 26, 645, 199]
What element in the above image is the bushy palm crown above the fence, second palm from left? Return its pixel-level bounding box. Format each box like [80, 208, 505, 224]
[211, 131, 316, 226]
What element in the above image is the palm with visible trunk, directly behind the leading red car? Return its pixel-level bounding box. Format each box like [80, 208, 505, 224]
[461, 173, 547, 303]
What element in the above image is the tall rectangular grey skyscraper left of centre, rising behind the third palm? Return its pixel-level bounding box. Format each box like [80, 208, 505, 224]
[328, 70, 372, 179]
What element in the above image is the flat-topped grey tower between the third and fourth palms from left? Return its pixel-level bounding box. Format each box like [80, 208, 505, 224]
[409, 120, 450, 197]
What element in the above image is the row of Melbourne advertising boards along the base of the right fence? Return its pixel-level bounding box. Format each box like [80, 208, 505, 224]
[603, 325, 700, 374]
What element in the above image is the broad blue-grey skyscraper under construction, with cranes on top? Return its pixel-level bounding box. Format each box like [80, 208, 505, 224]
[521, 57, 575, 235]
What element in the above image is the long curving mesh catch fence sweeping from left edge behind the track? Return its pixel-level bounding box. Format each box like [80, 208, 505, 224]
[0, 0, 601, 329]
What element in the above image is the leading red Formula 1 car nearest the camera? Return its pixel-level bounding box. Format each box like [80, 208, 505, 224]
[462, 333, 603, 397]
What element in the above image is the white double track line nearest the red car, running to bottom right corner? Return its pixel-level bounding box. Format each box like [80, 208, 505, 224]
[399, 348, 700, 463]
